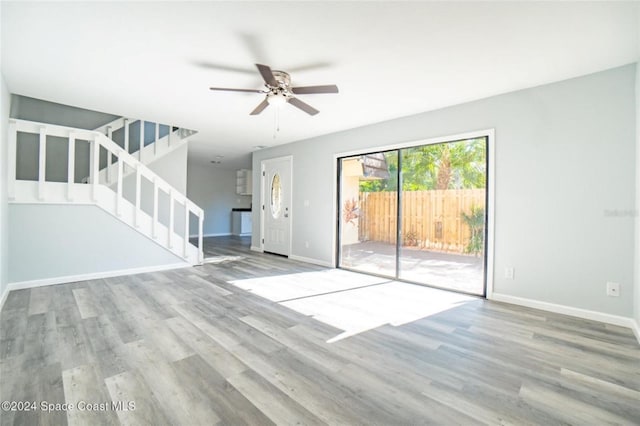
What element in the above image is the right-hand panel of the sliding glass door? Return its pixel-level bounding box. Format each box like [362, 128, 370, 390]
[398, 138, 487, 294]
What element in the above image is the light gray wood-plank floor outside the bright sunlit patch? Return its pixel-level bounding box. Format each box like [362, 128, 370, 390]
[0, 238, 640, 425]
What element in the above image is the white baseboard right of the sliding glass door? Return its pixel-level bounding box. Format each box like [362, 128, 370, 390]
[491, 293, 640, 332]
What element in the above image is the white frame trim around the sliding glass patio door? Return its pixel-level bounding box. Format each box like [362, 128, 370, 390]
[331, 129, 495, 299]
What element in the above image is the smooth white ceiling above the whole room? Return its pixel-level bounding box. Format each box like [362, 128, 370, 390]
[1, 1, 640, 168]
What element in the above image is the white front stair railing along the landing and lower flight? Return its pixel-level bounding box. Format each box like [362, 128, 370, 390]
[7, 119, 204, 263]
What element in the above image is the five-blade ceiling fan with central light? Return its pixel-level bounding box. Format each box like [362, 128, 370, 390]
[210, 64, 338, 115]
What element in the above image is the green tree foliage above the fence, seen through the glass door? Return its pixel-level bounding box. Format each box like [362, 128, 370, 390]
[360, 138, 486, 192]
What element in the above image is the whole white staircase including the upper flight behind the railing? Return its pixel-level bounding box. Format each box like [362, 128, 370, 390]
[7, 118, 204, 265]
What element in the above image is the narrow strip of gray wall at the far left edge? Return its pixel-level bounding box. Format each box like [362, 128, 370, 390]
[0, 74, 11, 299]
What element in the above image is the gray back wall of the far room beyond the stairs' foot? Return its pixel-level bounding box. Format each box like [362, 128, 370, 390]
[187, 162, 251, 235]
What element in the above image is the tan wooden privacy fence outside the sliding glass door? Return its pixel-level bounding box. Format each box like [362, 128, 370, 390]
[358, 188, 485, 253]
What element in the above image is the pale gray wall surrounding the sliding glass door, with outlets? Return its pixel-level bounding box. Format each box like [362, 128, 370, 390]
[253, 64, 636, 317]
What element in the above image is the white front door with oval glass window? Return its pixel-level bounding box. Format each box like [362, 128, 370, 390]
[262, 157, 291, 256]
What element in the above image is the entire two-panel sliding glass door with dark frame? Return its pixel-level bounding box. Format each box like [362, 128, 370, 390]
[339, 137, 487, 295]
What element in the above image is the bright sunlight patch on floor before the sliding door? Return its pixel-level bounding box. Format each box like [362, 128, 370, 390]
[231, 269, 478, 343]
